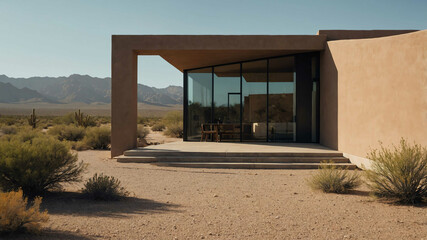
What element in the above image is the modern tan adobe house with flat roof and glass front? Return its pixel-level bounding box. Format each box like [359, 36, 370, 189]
[111, 30, 427, 167]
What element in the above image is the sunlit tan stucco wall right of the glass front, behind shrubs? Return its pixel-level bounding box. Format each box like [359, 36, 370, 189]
[320, 30, 427, 160]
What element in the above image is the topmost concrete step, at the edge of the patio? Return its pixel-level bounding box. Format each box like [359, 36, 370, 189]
[124, 149, 343, 157]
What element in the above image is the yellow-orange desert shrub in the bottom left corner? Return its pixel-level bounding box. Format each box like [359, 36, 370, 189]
[0, 190, 49, 235]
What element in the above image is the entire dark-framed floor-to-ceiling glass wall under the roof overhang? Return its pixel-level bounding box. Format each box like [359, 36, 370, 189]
[184, 53, 319, 142]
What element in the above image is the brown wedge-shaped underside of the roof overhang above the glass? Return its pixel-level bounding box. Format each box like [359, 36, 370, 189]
[150, 50, 309, 72]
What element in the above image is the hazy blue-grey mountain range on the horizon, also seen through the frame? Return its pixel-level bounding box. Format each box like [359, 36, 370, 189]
[0, 74, 183, 105]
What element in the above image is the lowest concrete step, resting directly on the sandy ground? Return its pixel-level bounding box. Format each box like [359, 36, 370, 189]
[151, 162, 356, 170]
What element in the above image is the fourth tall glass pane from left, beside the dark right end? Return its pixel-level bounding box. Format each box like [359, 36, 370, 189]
[268, 56, 296, 142]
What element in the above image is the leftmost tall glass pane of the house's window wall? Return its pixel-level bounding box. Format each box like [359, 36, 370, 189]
[188, 67, 212, 140]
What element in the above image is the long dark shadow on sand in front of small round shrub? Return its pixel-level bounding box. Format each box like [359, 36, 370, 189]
[42, 192, 180, 218]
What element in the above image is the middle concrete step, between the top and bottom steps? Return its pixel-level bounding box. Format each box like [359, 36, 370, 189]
[116, 155, 350, 163]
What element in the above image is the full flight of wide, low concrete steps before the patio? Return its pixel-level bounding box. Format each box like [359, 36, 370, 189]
[115, 149, 356, 169]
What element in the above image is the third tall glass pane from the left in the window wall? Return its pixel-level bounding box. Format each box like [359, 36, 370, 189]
[242, 60, 267, 142]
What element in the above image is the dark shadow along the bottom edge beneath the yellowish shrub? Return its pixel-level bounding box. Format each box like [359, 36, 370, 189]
[0, 230, 95, 240]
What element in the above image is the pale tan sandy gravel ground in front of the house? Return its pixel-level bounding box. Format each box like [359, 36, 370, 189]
[9, 151, 427, 239]
